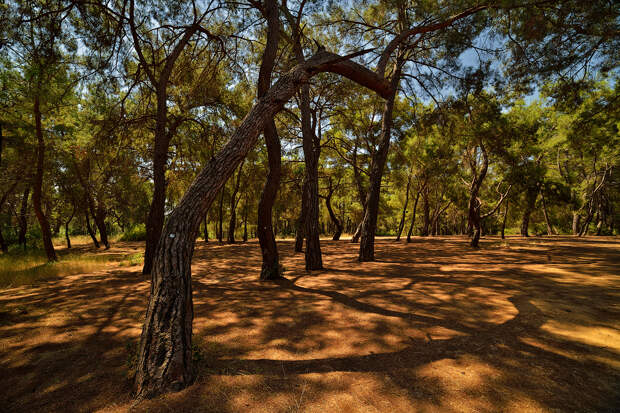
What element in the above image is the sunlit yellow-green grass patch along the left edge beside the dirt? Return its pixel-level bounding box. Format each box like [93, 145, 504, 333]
[0, 250, 118, 288]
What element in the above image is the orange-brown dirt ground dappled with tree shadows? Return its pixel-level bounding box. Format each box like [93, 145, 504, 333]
[0, 237, 620, 413]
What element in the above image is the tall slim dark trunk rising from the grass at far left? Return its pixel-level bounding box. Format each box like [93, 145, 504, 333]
[32, 95, 58, 261]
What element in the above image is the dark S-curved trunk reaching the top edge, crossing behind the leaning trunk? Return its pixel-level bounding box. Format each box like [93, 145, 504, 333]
[256, 0, 282, 280]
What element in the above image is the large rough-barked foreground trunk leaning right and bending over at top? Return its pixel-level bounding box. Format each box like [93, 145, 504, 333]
[135, 41, 387, 398]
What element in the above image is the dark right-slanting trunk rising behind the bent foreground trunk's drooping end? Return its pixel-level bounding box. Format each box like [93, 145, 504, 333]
[359, 56, 404, 262]
